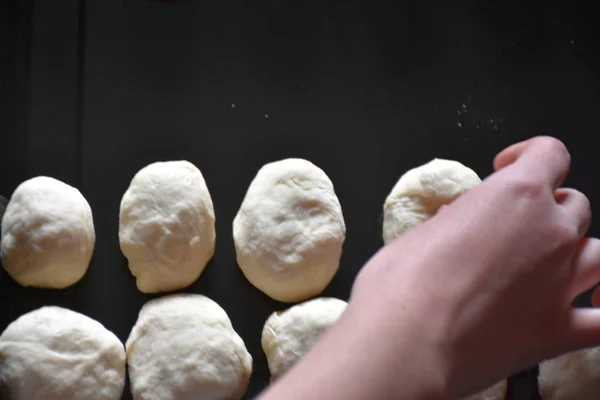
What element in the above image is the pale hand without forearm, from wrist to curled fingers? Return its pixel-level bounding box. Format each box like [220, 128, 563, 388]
[349, 137, 600, 397]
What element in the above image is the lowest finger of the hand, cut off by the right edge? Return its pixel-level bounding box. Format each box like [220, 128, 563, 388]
[566, 308, 600, 350]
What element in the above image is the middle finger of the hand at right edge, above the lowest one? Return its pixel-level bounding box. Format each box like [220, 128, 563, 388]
[571, 238, 600, 300]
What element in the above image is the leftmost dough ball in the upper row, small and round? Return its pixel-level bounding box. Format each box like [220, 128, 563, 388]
[1, 176, 96, 289]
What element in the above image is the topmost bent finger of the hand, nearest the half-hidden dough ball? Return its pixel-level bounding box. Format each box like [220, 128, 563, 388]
[494, 136, 571, 189]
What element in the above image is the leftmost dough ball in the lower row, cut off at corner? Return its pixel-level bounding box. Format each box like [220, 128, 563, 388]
[0, 306, 125, 400]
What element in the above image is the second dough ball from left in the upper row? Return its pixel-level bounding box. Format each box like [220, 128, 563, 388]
[119, 161, 215, 293]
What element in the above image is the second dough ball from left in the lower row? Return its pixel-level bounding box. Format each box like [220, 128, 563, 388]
[126, 294, 252, 400]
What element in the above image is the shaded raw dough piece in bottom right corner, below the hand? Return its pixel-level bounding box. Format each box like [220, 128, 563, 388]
[538, 347, 600, 400]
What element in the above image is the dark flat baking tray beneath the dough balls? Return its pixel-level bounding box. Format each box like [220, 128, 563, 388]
[0, 0, 600, 400]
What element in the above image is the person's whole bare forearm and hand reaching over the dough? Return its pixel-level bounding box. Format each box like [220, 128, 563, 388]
[259, 137, 600, 400]
